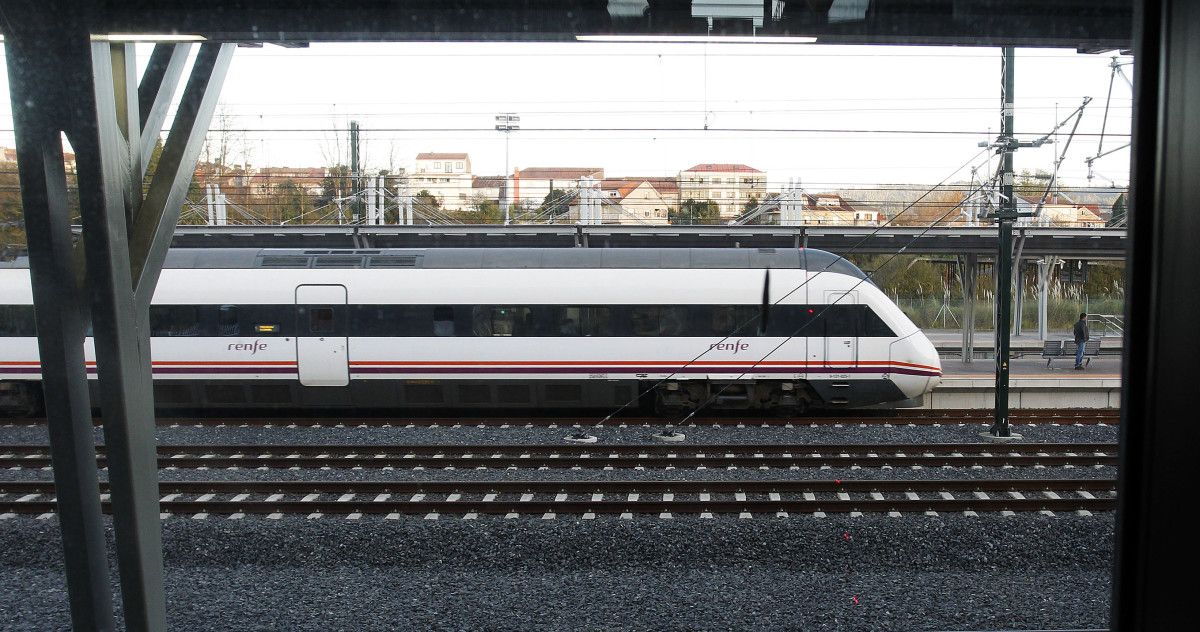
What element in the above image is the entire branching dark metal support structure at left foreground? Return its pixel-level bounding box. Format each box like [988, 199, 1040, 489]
[5, 0, 234, 631]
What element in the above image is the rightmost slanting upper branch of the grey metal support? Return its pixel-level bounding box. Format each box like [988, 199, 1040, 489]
[130, 44, 236, 311]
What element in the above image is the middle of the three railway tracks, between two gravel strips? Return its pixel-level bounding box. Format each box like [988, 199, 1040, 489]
[0, 443, 1117, 470]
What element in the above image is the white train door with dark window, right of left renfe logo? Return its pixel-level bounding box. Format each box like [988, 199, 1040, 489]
[296, 285, 350, 386]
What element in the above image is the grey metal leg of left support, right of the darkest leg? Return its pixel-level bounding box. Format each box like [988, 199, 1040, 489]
[68, 43, 166, 631]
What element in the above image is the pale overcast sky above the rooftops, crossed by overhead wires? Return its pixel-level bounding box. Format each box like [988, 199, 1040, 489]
[0, 43, 1133, 189]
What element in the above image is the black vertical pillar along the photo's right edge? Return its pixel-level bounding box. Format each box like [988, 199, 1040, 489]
[1112, 0, 1200, 632]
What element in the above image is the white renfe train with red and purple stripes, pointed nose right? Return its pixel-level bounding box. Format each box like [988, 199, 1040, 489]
[0, 248, 941, 415]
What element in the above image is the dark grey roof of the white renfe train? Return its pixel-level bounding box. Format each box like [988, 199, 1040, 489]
[0, 248, 866, 278]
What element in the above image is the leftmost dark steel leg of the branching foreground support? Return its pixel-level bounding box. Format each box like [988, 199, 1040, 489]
[5, 30, 113, 630]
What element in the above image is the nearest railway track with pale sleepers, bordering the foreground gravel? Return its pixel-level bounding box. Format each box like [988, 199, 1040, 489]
[0, 478, 1116, 518]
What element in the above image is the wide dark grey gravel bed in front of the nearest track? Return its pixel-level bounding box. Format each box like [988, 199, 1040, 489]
[0, 514, 1114, 631]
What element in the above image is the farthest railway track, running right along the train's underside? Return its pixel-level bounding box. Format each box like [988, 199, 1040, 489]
[0, 409, 1120, 428]
